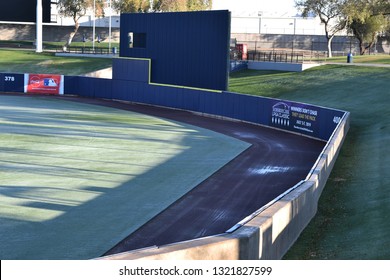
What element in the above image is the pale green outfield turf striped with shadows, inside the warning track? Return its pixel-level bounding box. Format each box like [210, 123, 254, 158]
[0, 95, 248, 260]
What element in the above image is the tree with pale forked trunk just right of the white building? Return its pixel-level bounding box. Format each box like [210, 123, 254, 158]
[295, 0, 348, 57]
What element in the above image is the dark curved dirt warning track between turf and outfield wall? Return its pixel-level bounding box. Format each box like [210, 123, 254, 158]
[58, 98, 325, 255]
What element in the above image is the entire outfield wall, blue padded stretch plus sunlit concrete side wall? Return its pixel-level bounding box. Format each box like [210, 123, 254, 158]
[0, 62, 349, 259]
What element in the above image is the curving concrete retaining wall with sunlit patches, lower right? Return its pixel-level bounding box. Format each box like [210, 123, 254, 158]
[100, 108, 350, 260]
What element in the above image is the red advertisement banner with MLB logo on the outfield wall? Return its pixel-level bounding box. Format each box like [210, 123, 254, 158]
[24, 74, 64, 94]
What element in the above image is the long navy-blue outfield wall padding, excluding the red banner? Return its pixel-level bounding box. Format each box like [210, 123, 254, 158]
[0, 71, 345, 140]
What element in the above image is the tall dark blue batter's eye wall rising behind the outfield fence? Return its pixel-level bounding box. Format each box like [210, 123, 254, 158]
[120, 11, 230, 90]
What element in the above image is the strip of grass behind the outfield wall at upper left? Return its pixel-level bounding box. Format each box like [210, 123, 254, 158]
[0, 49, 112, 75]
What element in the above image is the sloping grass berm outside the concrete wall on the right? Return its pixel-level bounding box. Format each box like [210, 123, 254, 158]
[230, 65, 390, 259]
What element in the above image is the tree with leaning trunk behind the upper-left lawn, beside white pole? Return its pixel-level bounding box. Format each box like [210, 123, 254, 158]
[57, 0, 104, 50]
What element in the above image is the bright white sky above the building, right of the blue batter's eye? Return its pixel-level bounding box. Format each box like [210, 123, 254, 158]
[213, 0, 297, 17]
